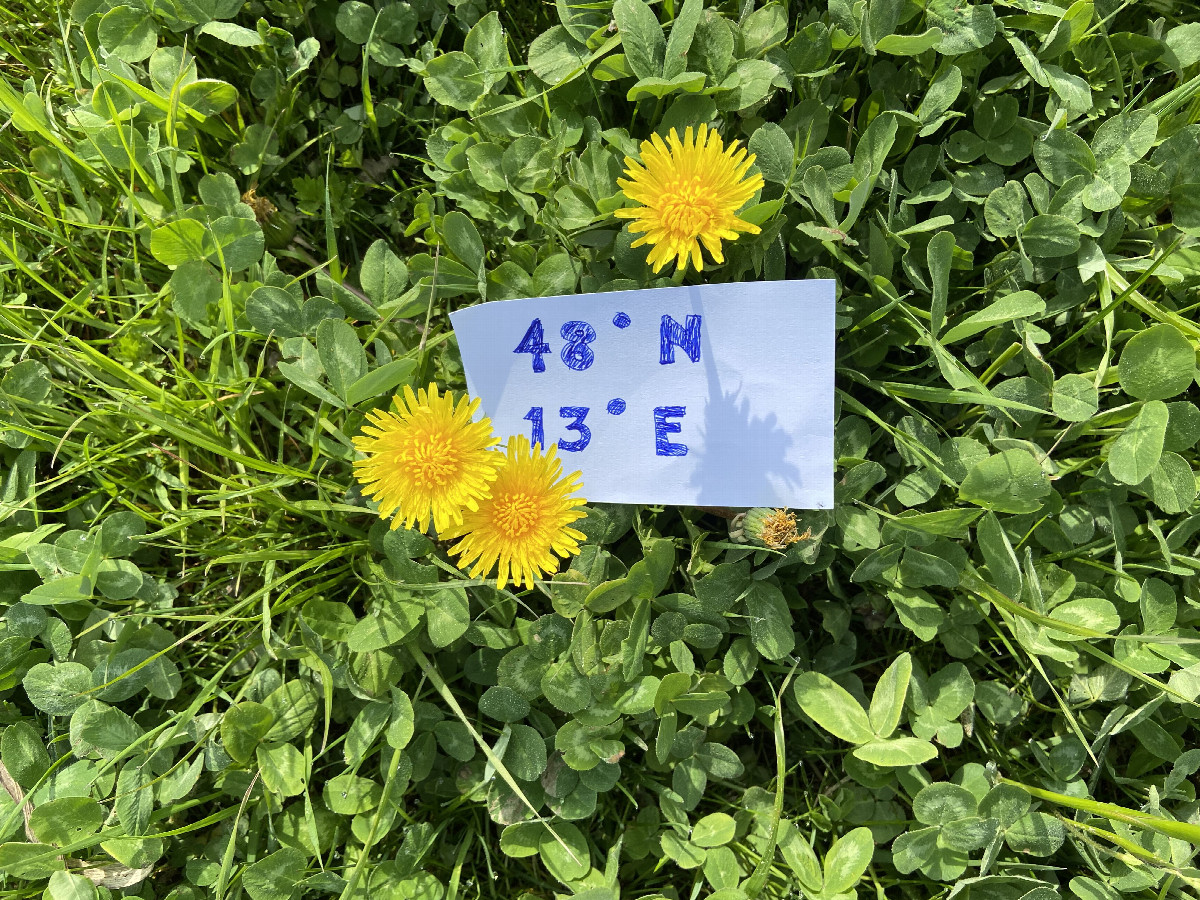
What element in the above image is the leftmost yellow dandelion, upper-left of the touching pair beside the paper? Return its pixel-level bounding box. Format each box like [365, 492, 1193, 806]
[354, 384, 502, 532]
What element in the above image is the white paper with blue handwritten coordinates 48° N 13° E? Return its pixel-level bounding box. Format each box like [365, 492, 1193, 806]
[450, 280, 834, 509]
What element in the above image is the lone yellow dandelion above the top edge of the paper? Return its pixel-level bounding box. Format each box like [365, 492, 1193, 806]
[613, 125, 763, 272]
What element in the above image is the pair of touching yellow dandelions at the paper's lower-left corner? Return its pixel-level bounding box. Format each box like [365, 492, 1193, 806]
[354, 384, 586, 588]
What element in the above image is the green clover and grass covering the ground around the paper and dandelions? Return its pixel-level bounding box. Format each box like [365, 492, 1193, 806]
[0, 0, 1200, 900]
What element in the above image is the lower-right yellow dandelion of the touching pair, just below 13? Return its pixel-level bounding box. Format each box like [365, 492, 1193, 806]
[446, 434, 587, 588]
